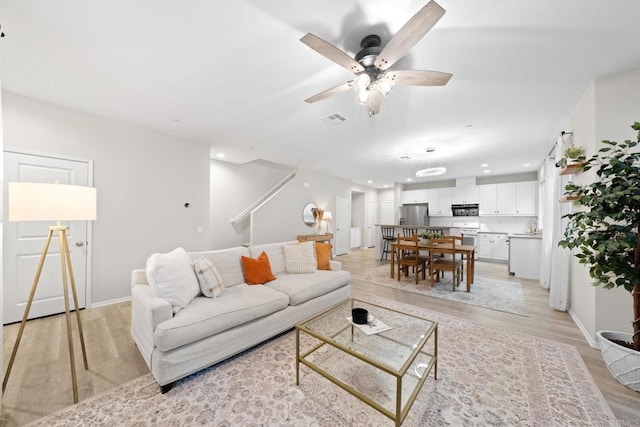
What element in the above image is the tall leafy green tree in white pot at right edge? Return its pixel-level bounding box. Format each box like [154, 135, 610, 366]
[558, 122, 640, 391]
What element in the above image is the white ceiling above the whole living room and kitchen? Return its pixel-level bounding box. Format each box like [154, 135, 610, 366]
[0, 0, 640, 188]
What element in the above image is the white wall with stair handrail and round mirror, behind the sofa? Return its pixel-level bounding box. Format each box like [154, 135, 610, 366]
[210, 160, 351, 249]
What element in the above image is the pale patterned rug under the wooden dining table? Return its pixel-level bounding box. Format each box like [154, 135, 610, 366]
[353, 265, 527, 316]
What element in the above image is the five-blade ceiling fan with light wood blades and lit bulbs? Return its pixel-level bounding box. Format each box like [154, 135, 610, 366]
[300, 1, 452, 117]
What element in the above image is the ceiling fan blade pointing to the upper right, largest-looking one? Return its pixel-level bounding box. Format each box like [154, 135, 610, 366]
[374, 0, 446, 70]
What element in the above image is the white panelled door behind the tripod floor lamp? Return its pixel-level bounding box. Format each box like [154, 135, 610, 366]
[3, 151, 89, 324]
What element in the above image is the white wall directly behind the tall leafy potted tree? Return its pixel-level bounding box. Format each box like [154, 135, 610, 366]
[569, 68, 640, 340]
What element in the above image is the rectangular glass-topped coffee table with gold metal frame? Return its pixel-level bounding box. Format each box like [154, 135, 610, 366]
[296, 299, 438, 426]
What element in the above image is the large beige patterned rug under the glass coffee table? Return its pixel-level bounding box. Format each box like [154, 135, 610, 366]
[26, 295, 616, 427]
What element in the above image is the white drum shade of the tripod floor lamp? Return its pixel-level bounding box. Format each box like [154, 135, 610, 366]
[9, 182, 97, 221]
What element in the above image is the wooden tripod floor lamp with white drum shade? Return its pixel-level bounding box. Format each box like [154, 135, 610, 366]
[2, 182, 96, 403]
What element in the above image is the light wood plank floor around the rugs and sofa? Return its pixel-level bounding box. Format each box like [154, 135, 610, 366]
[0, 249, 640, 426]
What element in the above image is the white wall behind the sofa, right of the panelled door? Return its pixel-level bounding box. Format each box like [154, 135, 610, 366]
[2, 92, 209, 304]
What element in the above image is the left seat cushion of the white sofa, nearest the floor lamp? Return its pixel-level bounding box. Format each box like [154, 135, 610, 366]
[153, 284, 289, 351]
